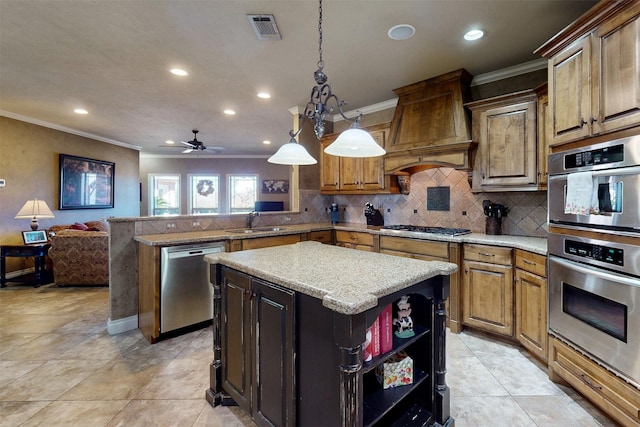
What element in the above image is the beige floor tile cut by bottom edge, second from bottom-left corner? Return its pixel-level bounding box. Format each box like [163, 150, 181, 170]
[20, 400, 128, 427]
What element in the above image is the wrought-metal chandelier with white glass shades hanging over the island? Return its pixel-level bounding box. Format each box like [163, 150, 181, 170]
[267, 0, 386, 165]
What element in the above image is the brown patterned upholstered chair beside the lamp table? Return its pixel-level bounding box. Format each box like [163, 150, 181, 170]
[49, 221, 109, 286]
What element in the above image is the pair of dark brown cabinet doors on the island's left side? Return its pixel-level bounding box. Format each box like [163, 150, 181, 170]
[220, 268, 296, 426]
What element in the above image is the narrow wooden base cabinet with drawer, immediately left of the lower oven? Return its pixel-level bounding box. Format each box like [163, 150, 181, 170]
[515, 249, 549, 361]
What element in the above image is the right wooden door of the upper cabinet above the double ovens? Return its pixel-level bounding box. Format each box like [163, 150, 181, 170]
[592, 3, 640, 134]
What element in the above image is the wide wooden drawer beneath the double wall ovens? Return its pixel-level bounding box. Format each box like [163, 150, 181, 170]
[549, 337, 640, 426]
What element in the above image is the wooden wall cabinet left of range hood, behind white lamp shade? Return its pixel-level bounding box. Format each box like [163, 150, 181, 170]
[320, 123, 399, 194]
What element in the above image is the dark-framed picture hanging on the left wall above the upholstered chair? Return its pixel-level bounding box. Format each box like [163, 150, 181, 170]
[58, 154, 116, 209]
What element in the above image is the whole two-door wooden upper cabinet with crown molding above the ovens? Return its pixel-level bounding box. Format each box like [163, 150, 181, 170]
[537, 0, 640, 146]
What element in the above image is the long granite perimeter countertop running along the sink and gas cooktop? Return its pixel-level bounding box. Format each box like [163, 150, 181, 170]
[135, 223, 547, 255]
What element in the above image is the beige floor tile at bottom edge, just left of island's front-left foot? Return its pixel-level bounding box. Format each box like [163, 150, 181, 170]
[107, 399, 209, 427]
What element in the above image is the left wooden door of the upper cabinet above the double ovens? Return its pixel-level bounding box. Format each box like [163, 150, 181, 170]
[549, 36, 591, 145]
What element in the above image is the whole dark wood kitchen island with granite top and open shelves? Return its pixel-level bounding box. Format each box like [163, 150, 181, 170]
[205, 242, 458, 426]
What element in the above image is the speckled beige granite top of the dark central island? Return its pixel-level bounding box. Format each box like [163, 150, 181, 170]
[204, 242, 458, 315]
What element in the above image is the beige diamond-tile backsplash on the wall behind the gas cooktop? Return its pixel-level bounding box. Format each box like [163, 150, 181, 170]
[330, 168, 547, 237]
